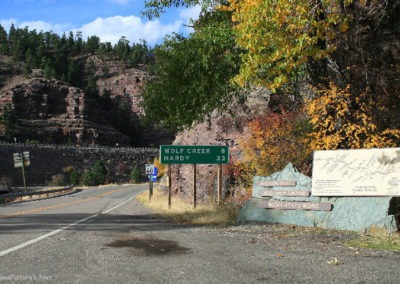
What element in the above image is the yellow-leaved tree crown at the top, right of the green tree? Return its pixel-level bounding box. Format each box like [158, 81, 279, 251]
[220, 0, 349, 90]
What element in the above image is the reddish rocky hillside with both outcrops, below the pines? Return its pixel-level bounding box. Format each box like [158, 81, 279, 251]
[0, 56, 172, 146]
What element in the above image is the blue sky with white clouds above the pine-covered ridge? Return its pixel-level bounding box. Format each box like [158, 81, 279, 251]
[0, 0, 200, 45]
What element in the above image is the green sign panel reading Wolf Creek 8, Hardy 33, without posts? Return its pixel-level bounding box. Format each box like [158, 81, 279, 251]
[160, 145, 229, 164]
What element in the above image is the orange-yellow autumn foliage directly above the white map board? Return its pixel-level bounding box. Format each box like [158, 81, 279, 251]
[305, 84, 400, 150]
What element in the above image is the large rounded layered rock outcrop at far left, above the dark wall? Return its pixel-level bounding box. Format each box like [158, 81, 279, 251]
[0, 79, 130, 145]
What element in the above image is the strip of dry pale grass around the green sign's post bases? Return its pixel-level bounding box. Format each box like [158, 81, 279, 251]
[136, 188, 239, 226]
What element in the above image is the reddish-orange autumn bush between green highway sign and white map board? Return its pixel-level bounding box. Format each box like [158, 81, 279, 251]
[224, 110, 312, 199]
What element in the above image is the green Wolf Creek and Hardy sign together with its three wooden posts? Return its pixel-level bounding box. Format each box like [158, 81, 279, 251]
[160, 145, 229, 208]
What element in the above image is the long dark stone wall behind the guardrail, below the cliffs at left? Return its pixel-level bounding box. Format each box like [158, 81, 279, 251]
[0, 143, 158, 186]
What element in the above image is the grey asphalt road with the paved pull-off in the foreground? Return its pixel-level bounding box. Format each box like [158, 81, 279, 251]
[0, 185, 400, 284]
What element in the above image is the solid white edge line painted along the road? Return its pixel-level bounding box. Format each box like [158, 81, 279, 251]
[0, 193, 138, 257]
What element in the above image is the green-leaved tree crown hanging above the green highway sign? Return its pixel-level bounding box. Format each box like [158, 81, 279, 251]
[142, 8, 240, 131]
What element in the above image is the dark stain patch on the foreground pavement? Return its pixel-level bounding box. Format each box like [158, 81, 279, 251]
[107, 238, 190, 256]
